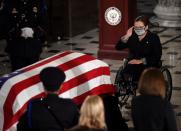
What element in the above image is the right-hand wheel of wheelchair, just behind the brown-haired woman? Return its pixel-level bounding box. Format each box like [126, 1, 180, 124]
[161, 67, 173, 101]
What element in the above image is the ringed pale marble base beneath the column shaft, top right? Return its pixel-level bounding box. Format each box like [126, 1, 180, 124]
[150, 4, 181, 27]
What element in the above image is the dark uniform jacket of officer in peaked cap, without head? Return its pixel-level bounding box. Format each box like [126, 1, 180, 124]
[17, 94, 79, 131]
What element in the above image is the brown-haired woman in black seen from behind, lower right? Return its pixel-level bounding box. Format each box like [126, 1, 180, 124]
[131, 68, 177, 131]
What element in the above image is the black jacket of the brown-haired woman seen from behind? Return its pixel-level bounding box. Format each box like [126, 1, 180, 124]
[132, 95, 177, 131]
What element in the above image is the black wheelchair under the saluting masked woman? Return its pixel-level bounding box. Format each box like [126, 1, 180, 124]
[114, 60, 173, 107]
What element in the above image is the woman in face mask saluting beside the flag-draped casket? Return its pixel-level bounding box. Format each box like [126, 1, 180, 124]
[115, 16, 162, 80]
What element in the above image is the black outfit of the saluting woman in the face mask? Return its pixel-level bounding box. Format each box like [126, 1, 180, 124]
[115, 31, 162, 80]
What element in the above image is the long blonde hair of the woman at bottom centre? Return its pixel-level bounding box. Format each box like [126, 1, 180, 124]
[79, 96, 105, 128]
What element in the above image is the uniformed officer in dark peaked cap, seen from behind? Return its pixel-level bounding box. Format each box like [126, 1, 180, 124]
[17, 67, 79, 131]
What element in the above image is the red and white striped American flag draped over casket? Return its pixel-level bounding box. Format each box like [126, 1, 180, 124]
[0, 51, 115, 131]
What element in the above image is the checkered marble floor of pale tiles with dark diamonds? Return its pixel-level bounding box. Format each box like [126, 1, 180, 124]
[0, 0, 181, 131]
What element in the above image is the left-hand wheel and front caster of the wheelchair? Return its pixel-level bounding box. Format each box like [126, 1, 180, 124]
[114, 67, 136, 106]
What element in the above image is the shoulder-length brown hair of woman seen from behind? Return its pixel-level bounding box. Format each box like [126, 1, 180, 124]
[138, 68, 166, 98]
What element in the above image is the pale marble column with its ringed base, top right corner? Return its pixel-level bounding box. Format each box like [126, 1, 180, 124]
[150, 0, 181, 27]
